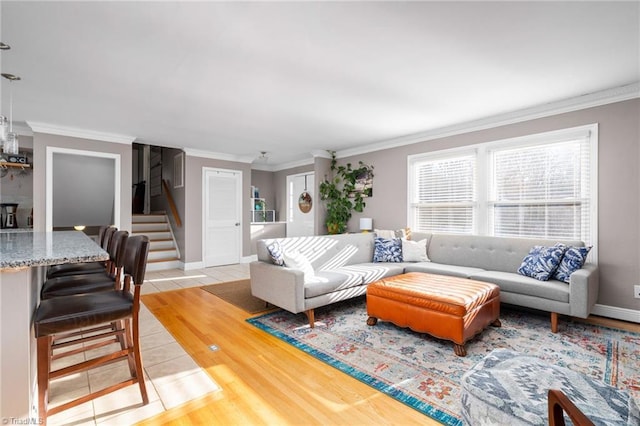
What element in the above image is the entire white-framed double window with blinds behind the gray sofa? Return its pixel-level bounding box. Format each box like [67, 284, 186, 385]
[409, 124, 597, 256]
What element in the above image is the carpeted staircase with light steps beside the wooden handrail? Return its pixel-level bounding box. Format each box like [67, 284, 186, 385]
[131, 214, 182, 271]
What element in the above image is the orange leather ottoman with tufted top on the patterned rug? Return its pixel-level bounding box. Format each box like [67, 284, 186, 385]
[367, 272, 501, 356]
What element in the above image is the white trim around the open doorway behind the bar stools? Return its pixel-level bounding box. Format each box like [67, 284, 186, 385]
[45, 146, 122, 232]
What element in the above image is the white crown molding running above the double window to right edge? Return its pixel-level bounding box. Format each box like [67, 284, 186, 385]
[336, 82, 640, 158]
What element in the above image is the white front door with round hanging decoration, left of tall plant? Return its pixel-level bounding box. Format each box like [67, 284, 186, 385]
[287, 173, 318, 237]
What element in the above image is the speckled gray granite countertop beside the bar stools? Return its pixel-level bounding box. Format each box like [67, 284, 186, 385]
[0, 231, 109, 270]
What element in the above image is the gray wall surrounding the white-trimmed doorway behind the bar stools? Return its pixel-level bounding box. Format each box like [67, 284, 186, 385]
[33, 133, 131, 232]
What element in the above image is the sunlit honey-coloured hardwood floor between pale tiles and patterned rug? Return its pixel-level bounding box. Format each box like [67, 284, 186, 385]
[139, 288, 439, 425]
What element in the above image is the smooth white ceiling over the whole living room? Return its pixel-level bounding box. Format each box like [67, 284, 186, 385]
[0, 1, 640, 166]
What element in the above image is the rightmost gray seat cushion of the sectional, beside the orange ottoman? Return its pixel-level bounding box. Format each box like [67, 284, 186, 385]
[469, 271, 569, 303]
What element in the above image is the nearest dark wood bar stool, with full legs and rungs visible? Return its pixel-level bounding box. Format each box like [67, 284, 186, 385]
[34, 236, 149, 424]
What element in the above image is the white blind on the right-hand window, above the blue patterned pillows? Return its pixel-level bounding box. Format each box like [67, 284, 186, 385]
[488, 138, 592, 242]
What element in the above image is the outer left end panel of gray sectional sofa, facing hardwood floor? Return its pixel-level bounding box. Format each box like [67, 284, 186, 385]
[249, 261, 306, 314]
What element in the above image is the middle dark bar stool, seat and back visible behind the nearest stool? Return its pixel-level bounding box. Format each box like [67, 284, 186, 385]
[40, 228, 129, 300]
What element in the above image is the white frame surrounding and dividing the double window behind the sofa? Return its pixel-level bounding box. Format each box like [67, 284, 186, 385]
[407, 123, 598, 263]
